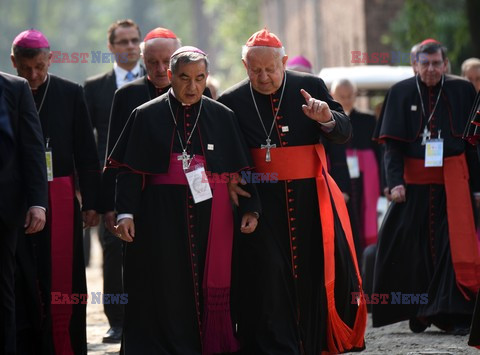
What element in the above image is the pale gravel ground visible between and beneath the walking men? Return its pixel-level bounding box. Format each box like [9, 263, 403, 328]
[87, 233, 480, 355]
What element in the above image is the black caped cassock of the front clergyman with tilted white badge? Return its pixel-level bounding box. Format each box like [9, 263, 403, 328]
[111, 93, 260, 354]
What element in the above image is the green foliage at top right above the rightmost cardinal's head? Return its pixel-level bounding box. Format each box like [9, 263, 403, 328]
[382, 0, 471, 73]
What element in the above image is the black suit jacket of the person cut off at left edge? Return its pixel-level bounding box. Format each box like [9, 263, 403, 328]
[0, 72, 48, 225]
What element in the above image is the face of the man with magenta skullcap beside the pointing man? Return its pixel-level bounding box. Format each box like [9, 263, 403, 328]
[168, 60, 208, 105]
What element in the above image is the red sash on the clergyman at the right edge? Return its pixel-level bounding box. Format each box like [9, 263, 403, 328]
[404, 154, 480, 300]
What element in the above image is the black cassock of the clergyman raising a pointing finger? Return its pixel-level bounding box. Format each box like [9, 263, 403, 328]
[219, 70, 364, 354]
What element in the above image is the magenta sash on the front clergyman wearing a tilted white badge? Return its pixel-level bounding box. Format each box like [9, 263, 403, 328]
[146, 154, 239, 355]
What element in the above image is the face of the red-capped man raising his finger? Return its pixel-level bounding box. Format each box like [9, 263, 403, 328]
[243, 48, 288, 95]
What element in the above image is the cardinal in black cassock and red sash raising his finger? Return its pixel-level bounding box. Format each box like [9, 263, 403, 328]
[219, 29, 366, 354]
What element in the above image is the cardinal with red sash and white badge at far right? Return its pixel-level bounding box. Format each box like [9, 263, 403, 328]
[372, 39, 480, 334]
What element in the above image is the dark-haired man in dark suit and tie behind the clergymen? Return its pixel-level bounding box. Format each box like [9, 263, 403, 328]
[84, 20, 145, 343]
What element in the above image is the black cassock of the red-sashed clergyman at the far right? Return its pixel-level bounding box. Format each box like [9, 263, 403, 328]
[372, 75, 480, 330]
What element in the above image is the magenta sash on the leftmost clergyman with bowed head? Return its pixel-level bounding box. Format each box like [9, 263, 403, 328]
[48, 176, 75, 355]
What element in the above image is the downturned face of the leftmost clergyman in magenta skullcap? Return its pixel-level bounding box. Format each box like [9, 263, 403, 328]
[11, 51, 52, 90]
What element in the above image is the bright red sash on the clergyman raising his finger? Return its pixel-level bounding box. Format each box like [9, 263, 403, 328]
[251, 144, 367, 353]
